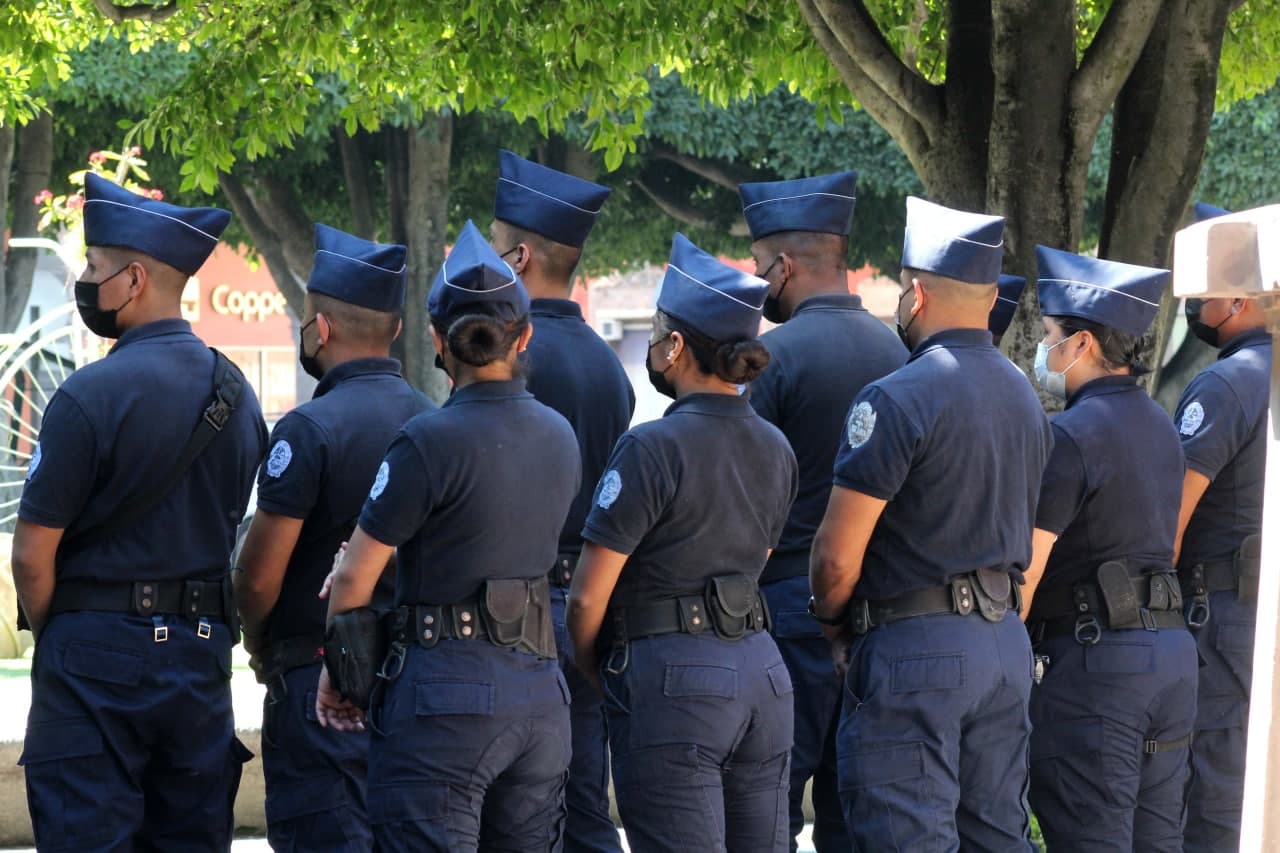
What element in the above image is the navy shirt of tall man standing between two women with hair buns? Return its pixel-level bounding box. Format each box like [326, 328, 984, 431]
[525, 300, 636, 558]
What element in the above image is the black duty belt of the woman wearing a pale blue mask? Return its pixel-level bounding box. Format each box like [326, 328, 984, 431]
[1030, 560, 1187, 646]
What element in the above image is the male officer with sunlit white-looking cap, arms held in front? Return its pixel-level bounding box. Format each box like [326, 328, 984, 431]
[809, 199, 1051, 850]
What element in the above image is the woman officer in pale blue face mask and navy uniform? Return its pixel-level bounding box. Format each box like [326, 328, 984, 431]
[1025, 246, 1196, 850]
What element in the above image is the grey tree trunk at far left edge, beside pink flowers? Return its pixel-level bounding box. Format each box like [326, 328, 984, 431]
[0, 113, 54, 332]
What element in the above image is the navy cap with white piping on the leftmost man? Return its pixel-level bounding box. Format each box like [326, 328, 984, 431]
[84, 172, 232, 275]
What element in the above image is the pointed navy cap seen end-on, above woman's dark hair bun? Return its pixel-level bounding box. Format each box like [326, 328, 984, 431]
[426, 219, 529, 320]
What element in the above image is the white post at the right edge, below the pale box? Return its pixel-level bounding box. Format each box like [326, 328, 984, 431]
[1240, 293, 1280, 853]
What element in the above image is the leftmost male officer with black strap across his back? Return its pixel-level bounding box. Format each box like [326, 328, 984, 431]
[13, 174, 266, 850]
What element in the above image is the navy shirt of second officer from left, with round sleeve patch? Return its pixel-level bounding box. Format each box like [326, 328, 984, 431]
[257, 359, 435, 642]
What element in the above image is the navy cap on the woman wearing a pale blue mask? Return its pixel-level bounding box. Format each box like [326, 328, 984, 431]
[1036, 246, 1169, 337]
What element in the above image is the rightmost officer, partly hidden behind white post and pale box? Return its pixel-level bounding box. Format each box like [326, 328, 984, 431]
[1174, 204, 1271, 853]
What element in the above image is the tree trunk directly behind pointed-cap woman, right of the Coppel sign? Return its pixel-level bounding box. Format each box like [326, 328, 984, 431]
[403, 111, 453, 400]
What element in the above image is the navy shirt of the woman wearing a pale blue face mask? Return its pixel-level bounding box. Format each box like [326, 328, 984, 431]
[1033, 377, 1183, 601]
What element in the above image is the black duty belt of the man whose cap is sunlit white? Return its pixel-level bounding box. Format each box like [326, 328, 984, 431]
[849, 569, 1023, 635]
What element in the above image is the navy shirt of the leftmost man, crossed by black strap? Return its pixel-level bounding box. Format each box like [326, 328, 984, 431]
[18, 320, 266, 580]
